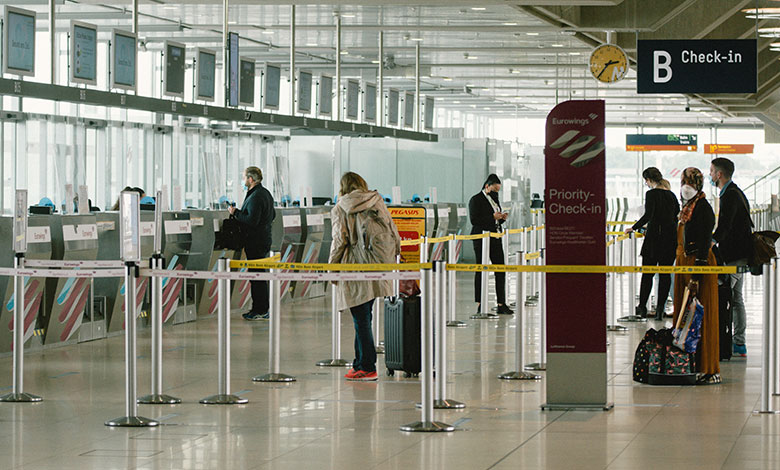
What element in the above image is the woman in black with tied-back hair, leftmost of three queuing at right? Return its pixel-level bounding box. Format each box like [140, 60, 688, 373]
[626, 166, 680, 320]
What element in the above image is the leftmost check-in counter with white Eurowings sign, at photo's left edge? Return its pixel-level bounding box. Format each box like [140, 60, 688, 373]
[0, 215, 57, 352]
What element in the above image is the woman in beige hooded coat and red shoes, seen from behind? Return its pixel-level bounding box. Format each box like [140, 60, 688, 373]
[328, 172, 401, 381]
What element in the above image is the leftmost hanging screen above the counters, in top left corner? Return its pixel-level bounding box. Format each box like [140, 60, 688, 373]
[3, 6, 35, 75]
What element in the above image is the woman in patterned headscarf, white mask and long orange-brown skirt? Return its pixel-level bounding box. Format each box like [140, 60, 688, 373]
[674, 167, 720, 384]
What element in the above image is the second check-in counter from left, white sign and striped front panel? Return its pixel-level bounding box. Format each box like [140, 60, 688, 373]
[43, 214, 98, 345]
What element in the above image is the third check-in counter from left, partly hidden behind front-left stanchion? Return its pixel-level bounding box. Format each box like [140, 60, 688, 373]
[106, 211, 155, 334]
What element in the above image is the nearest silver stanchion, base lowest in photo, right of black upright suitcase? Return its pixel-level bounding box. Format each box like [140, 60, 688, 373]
[401, 269, 455, 432]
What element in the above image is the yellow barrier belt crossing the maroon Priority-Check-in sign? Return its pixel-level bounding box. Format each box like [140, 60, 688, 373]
[447, 264, 737, 274]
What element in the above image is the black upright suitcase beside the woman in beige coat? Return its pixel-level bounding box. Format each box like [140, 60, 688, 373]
[385, 296, 422, 377]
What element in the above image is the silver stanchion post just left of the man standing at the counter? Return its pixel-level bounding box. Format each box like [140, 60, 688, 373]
[200, 258, 249, 405]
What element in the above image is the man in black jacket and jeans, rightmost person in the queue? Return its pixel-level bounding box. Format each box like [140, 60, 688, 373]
[710, 158, 753, 357]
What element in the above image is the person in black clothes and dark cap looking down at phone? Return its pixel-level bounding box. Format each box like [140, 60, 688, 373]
[469, 174, 515, 315]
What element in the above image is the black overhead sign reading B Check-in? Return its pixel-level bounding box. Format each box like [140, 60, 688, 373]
[636, 39, 756, 93]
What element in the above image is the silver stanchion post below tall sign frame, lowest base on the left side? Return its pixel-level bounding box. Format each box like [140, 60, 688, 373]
[105, 261, 160, 427]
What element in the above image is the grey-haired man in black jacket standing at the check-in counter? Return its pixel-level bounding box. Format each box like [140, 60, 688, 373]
[228, 166, 276, 321]
